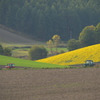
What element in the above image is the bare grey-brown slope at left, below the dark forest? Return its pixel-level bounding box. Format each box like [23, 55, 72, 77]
[0, 28, 44, 44]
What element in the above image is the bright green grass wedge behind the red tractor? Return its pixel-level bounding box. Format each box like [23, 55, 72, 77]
[0, 55, 69, 68]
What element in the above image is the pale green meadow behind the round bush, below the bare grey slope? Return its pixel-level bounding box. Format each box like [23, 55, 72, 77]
[1, 43, 68, 58]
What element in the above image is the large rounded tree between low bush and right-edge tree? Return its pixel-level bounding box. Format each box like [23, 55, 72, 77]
[79, 25, 95, 46]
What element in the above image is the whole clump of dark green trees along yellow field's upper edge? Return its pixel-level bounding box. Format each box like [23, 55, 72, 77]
[67, 23, 100, 51]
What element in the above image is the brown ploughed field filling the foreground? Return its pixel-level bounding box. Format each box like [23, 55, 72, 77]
[0, 68, 100, 100]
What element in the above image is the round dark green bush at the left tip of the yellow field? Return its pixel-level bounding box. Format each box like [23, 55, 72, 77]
[29, 45, 48, 60]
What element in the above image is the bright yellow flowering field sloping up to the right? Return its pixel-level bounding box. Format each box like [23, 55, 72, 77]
[37, 44, 100, 65]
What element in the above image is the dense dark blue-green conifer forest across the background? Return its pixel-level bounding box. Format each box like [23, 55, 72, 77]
[0, 0, 100, 41]
